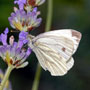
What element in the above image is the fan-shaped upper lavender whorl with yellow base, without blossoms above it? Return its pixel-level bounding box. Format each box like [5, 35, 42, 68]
[9, 7, 42, 31]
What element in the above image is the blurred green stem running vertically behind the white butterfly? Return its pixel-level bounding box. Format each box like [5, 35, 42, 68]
[32, 0, 53, 90]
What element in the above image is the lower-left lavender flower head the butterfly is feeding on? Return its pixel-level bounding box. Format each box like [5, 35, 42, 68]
[0, 29, 31, 68]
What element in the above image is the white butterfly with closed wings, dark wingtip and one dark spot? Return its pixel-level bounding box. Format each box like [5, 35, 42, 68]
[29, 29, 81, 76]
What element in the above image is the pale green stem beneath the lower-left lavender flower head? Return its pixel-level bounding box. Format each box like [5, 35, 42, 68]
[0, 66, 13, 90]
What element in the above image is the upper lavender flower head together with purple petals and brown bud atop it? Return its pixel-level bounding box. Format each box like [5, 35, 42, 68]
[8, 0, 45, 31]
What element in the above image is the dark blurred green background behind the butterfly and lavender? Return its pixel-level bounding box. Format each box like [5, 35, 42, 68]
[0, 0, 90, 90]
